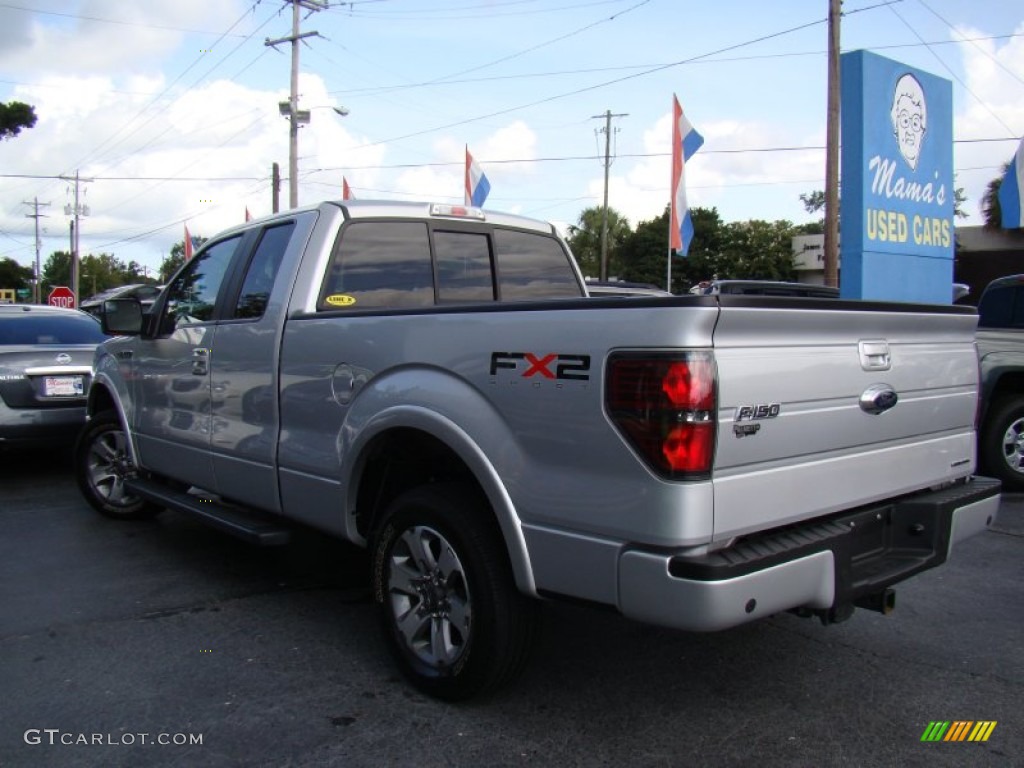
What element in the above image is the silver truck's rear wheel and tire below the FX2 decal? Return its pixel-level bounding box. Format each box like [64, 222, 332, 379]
[373, 483, 538, 700]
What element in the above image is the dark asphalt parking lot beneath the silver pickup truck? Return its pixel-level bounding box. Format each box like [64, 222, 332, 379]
[0, 453, 1024, 767]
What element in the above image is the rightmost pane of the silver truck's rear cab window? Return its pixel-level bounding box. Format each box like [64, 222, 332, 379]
[495, 229, 583, 301]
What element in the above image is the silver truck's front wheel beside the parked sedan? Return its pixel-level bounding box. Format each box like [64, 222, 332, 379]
[75, 411, 160, 520]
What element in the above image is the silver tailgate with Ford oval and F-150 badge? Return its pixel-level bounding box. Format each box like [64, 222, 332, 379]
[714, 297, 978, 540]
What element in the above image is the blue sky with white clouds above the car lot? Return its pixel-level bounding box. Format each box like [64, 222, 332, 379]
[0, 0, 1024, 284]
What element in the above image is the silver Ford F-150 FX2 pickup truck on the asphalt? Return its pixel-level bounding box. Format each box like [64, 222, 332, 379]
[76, 201, 999, 699]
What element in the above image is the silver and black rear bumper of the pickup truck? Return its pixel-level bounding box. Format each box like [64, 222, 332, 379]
[618, 477, 999, 631]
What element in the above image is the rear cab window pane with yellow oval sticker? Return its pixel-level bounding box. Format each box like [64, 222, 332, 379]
[318, 221, 434, 309]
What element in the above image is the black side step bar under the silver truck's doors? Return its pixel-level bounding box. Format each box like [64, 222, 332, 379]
[125, 477, 291, 547]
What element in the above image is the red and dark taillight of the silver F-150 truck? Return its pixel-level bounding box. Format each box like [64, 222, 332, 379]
[605, 351, 716, 479]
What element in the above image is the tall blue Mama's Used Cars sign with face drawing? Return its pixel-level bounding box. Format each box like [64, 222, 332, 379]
[840, 50, 954, 304]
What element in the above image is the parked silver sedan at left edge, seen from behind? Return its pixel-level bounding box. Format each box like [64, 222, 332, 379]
[0, 304, 109, 447]
